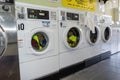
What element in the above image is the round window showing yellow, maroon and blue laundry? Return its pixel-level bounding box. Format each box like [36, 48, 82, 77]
[31, 32, 49, 52]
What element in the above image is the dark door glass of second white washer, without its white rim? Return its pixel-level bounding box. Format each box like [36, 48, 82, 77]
[67, 27, 80, 48]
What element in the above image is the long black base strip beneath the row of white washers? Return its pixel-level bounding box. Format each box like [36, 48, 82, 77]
[36, 51, 111, 80]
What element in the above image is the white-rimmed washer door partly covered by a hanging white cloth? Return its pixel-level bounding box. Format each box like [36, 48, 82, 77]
[87, 26, 100, 45]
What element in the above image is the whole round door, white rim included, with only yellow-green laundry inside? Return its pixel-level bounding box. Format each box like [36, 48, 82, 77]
[63, 27, 82, 49]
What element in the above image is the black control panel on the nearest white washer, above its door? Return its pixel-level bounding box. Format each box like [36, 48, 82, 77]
[27, 8, 49, 20]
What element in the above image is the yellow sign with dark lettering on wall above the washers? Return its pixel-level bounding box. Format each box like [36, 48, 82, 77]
[62, 0, 97, 11]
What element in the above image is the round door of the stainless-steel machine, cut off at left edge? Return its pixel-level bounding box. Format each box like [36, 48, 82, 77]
[0, 26, 7, 58]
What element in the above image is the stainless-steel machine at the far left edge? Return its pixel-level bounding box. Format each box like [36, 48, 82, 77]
[0, 0, 20, 80]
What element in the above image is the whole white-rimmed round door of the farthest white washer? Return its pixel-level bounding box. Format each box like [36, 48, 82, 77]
[102, 26, 112, 42]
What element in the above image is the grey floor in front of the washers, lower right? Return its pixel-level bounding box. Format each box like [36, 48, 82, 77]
[61, 53, 120, 80]
